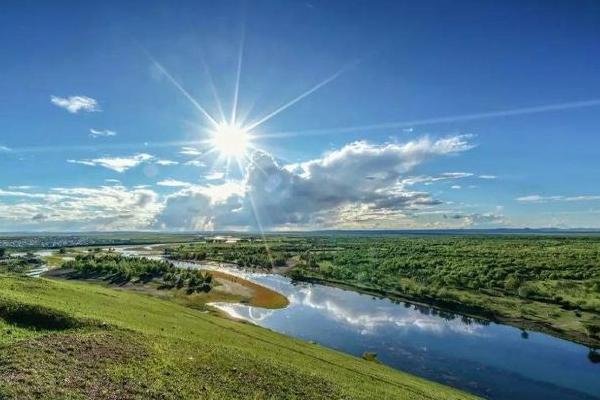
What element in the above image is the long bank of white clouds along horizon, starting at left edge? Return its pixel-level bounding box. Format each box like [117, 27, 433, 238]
[7, 136, 486, 230]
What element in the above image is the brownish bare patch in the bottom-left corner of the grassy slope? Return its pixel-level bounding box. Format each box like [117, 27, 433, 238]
[0, 331, 148, 399]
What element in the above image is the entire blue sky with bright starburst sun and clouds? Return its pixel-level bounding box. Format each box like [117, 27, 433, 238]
[0, 0, 600, 231]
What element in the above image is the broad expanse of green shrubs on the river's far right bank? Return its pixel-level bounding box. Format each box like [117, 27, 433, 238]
[276, 236, 600, 312]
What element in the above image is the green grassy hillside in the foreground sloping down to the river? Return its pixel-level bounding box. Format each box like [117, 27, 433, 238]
[0, 276, 478, 399]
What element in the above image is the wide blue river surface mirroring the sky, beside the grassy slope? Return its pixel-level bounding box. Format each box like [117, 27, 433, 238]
[166, 263, 600, 400]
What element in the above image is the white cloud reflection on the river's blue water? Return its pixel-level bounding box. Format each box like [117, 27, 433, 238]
[209, 273, 484, 336]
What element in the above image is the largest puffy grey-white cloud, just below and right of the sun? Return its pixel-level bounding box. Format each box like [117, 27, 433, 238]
[158, 136, 473, 229]
